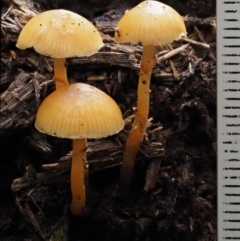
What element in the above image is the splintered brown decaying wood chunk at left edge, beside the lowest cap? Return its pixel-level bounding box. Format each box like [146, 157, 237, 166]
[0, 73, 52, 132]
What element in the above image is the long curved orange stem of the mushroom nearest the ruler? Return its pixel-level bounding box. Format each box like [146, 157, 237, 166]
[119, 44, 155, 191]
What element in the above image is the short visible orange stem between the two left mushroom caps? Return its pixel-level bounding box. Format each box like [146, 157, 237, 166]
[53, 58, 69, 89]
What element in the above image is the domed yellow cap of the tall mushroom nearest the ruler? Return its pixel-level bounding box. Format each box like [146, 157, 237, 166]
[114, 1, 187, 45]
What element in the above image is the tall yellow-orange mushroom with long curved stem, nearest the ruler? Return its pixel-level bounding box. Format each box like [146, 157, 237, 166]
[114, 1, 187, 190]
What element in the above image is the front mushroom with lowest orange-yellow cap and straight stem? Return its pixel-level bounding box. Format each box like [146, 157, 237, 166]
[35, 83, 124, 216]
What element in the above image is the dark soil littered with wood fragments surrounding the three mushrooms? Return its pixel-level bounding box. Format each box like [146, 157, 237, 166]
[0, 0, 217, 241]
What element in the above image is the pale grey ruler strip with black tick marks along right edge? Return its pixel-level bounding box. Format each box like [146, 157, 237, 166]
[217, 0, 240, 241]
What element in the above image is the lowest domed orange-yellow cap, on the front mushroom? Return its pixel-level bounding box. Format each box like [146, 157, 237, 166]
[35, 83, 124, 139]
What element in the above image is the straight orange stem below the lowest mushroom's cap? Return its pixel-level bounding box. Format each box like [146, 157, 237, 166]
[71, 138, 87, 216]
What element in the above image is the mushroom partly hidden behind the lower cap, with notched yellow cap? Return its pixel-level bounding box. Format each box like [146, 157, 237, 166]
[16, 9, 103, 88]
